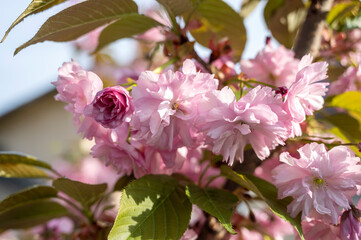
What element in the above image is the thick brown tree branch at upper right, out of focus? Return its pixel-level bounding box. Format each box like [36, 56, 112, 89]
[293, 0, 333, 58]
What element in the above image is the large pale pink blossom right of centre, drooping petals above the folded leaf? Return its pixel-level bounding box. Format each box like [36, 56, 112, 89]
[197, 86, 290, 164]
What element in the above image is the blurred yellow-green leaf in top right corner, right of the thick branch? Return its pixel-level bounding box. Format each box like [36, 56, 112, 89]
[326, 1, 361, 31]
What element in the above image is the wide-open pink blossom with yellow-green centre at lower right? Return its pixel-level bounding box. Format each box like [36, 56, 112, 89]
[273, 143, 361, 224]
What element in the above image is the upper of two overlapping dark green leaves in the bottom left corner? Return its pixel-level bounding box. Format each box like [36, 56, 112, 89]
[0, 186, 58, 213]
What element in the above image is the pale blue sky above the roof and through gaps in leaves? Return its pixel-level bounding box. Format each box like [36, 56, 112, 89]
[0, 0, 269, 116]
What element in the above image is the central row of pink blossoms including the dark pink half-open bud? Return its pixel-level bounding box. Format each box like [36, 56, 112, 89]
[54, 46, 327, 177]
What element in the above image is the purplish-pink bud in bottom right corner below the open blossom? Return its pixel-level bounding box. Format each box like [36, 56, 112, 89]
[340, 208, 361, 240]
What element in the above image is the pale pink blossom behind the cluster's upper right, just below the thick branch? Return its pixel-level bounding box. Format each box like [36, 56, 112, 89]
[241, 44, 299, 87]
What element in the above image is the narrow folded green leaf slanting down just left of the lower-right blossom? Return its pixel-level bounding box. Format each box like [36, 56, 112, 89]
[221, 165, 304, 239]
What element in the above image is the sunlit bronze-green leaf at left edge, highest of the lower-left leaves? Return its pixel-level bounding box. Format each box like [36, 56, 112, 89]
[0, 152, 52, 178]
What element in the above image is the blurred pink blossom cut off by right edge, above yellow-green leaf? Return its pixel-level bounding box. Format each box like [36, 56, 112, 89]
[329, 62, 361, 95]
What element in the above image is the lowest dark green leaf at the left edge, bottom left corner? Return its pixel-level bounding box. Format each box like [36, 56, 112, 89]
[0, 200, 70, 230]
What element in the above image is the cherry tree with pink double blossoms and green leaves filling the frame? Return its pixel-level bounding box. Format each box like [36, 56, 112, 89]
[0, 0, 361, 240]
